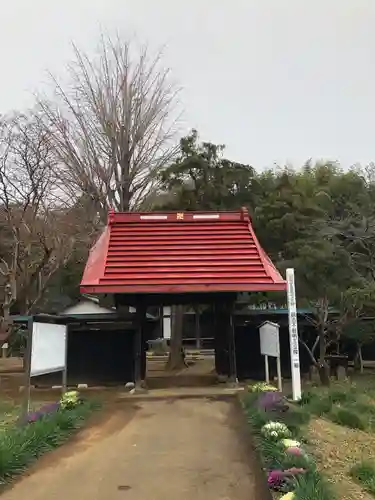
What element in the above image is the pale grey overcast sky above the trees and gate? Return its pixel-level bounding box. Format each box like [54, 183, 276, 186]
[0, 0, 375, 169]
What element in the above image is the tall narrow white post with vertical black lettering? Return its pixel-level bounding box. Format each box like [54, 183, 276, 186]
[286, 269, 301, 401]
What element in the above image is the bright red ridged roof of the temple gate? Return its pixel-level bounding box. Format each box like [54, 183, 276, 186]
[80, 209, 286, 294]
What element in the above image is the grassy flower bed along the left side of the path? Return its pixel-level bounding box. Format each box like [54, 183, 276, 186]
[0, 391, 97, 484]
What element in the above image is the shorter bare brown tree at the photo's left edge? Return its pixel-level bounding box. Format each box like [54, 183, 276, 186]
[0, 115, 76, 342]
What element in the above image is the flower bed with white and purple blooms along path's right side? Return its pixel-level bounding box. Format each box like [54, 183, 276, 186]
[242, 388, 335, 500]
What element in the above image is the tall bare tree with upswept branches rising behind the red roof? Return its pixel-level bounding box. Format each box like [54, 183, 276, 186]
[39, 36, 181, 220]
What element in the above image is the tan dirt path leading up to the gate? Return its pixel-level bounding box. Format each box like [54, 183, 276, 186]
[1, 399, 267, 500]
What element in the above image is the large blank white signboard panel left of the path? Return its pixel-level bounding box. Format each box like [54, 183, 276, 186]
[30, 321, 67, 377]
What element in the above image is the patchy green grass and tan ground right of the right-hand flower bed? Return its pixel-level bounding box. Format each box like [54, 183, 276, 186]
[300, 376, 375, 500]
